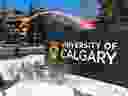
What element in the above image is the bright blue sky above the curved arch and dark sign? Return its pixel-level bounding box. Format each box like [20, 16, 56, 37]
[0, 0, 96, 16]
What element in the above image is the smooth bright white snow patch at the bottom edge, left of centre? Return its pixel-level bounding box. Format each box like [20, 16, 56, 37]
[7, 81, 74, 96]
